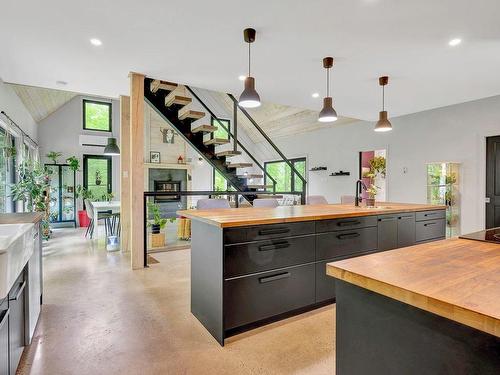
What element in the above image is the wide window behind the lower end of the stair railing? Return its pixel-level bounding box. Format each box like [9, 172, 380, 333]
[264, 158, 306, 192]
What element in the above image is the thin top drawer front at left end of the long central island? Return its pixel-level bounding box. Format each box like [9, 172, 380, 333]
[224, 221, 314, 245]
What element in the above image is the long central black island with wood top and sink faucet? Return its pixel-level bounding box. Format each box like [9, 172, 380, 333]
[178, 203, 446, 345]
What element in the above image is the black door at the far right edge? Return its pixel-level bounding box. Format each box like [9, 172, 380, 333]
[486, 136, 500, 228]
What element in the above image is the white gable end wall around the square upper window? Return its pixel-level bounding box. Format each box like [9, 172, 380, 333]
[38, 95, 120, 204]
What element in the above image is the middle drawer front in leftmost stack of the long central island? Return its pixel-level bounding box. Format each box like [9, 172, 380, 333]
[224, 235, 316, 277]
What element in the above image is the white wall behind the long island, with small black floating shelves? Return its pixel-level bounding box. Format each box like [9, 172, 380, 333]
[275, 96, 500, 233]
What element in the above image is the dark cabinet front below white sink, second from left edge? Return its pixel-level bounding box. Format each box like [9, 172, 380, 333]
[9, 272, 26, 374]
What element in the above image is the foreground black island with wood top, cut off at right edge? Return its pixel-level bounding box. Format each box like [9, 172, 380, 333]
[327, 239, 500, 375]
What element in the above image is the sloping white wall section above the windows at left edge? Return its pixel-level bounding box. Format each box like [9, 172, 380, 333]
[0, 78, 38, 141]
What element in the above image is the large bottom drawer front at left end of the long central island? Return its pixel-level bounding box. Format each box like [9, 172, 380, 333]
[224, 264, 315, 330]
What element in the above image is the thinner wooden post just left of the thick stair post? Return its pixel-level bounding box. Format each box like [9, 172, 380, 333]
[120, 95, 131, 252]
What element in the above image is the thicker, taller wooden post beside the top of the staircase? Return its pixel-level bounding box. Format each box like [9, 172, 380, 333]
[129, 73, 144, 270]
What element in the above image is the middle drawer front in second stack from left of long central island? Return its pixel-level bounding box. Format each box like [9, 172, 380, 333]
[316, 226, 378, 260]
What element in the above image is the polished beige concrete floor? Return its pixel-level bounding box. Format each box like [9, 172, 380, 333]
[18, 229, 335, 375]
